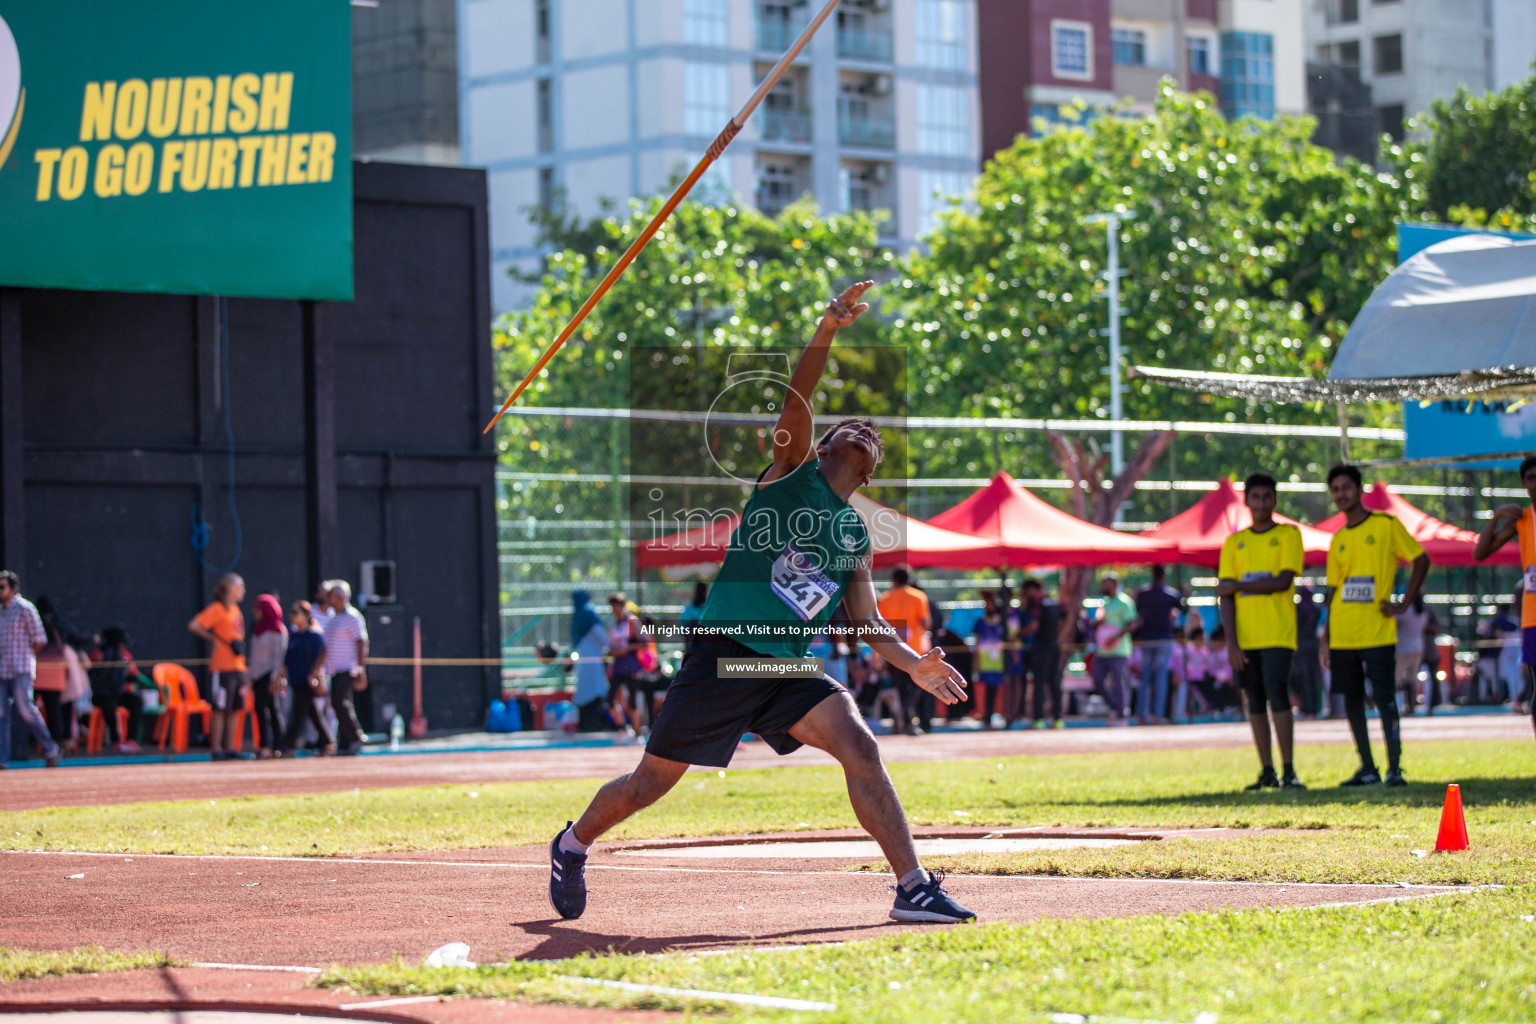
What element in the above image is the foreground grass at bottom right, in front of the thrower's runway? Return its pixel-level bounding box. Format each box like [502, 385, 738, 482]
[318, 886, 1536, 1024]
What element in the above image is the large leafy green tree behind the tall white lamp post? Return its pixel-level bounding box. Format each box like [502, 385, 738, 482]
[894, 88, 1404, 491]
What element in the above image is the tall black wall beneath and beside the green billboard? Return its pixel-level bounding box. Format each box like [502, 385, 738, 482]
[0, 163, 499, 728]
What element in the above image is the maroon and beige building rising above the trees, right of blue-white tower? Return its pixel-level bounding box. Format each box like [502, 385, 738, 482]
[977, 0, 1307, 154]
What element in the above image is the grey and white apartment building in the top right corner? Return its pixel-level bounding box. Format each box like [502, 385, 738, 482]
[1306, 0, 1536, 160]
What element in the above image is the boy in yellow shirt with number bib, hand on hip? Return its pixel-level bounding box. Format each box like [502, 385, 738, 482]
[1322, 465, 1430, 786]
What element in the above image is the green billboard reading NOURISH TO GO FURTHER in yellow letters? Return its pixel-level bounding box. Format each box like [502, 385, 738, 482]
[0, 0, 352, 299]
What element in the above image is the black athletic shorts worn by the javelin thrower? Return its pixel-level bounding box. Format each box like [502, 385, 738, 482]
[645, 634, 848, 768]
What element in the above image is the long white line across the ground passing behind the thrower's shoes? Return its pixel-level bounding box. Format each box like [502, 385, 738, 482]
[0, 851, 1455, 906]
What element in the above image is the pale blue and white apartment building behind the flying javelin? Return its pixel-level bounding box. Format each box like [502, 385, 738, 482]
[458, 0, 980, 309]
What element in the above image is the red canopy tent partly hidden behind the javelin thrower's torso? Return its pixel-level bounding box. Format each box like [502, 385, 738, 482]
[634, 494, 998, 570]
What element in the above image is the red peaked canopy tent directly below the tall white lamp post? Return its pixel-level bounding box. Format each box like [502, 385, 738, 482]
[928, 473, 1178, 568]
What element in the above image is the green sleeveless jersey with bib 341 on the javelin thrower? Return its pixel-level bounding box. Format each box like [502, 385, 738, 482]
[699, 459, 869, 659]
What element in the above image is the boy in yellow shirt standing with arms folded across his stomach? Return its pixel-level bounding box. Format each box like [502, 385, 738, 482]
[1217, 473, 1306, 789]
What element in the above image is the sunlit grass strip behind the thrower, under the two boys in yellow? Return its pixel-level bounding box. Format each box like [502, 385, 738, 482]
[0, 742, 1536, 884]
